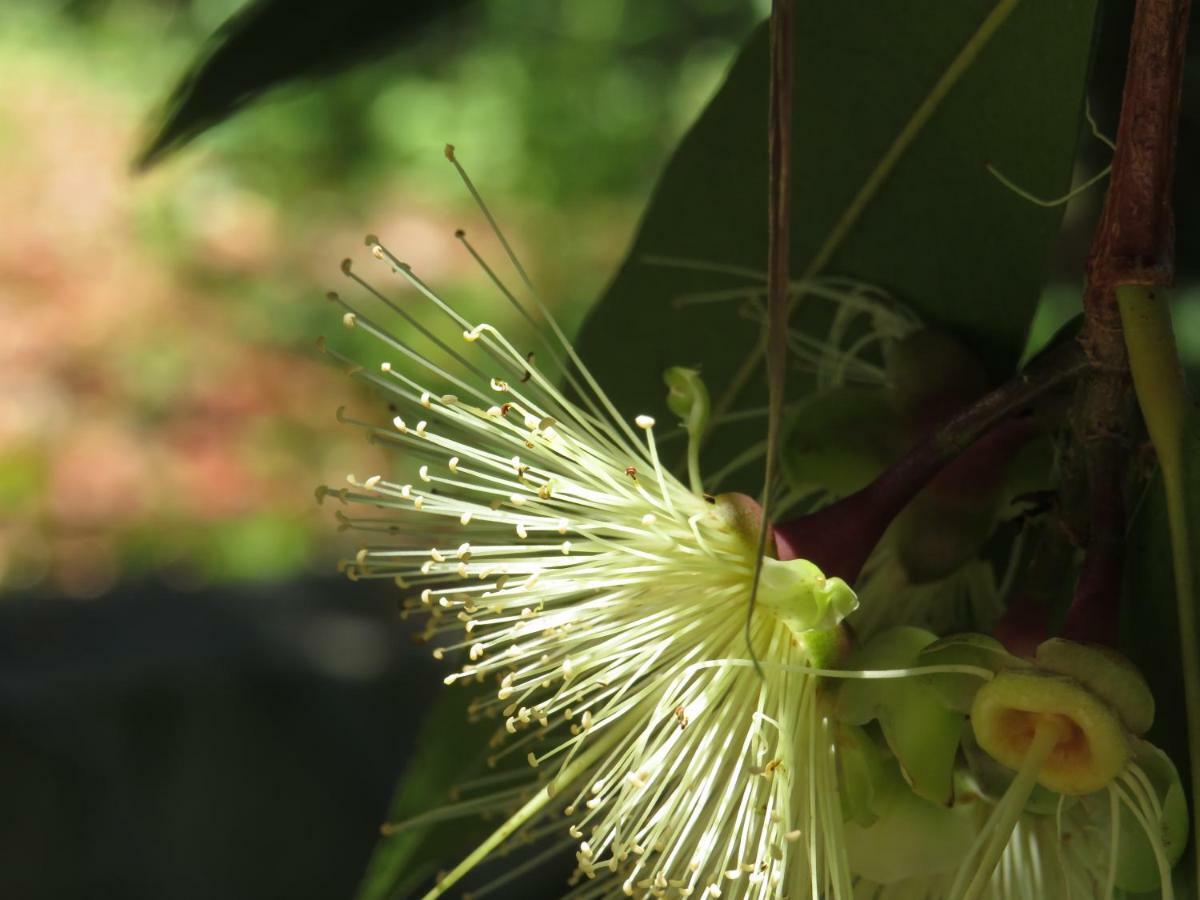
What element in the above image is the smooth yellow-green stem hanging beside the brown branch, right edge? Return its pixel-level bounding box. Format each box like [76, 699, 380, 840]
[1116, 284, 1200, 883]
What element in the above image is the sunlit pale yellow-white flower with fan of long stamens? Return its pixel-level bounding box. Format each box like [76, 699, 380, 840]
[320, 157, 856, 898]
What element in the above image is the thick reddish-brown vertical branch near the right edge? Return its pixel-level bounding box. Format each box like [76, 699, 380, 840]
[1067, 0, 1190, 636]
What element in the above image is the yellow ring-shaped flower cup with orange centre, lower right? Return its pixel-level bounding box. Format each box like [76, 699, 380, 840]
[971, 670, 1130, 794]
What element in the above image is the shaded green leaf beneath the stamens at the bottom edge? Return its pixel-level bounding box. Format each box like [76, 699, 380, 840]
[358, 690, 494, 900]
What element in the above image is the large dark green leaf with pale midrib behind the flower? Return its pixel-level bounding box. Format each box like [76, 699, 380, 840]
[580, 0, 1096, 491]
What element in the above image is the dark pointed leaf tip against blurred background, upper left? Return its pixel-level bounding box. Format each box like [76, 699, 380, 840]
[136, 0, 467, 169]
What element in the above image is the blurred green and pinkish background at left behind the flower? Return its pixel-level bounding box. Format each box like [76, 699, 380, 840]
[0, 0, 767, 598]
